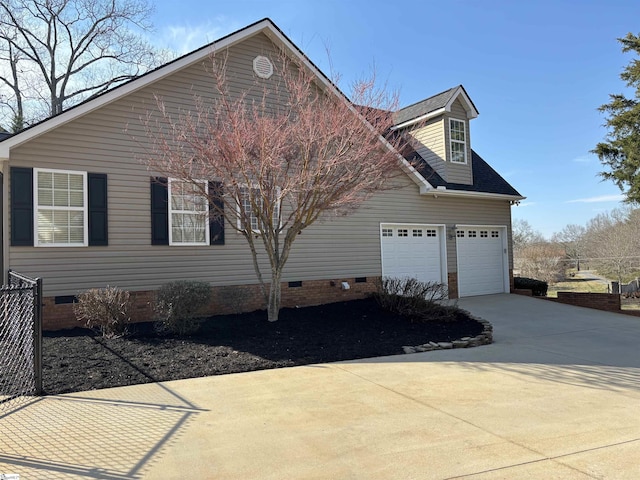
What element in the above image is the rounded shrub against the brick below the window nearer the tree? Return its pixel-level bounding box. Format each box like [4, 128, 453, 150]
[154, 280, 211, 335]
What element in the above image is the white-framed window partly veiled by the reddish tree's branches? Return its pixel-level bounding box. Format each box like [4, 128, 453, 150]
[169, 178, 209, 245]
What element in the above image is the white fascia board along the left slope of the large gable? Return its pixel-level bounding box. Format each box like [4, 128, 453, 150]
[0, 20, 281, 160]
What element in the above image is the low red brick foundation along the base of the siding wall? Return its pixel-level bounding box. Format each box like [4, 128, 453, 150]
[42, 277, 379, 330]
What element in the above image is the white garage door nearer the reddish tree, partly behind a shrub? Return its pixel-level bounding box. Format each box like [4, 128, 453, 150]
[380, 224, 444, 282]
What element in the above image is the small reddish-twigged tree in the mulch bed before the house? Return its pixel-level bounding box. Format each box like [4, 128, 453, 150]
[141, 54, 412, 321]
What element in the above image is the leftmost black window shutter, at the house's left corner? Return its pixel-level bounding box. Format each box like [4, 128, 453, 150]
[11, 167, 33, 246]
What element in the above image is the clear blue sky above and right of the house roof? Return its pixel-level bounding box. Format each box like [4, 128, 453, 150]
[153, 0, 640, 236]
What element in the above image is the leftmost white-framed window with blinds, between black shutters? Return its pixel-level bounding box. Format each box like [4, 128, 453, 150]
[33, 169, 88, 247]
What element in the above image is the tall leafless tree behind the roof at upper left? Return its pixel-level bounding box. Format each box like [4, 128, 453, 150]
[0, 0, 166, 130]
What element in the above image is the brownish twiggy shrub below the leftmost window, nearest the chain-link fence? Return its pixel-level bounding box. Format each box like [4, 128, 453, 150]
[73, 285, 131, 338]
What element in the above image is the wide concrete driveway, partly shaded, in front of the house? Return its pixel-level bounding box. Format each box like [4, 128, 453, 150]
[0, 295, 640, 480]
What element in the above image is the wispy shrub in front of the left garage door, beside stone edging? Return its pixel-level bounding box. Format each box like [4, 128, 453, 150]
[374, 277, 458, 322]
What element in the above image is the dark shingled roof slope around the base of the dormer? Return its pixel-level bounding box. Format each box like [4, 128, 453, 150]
[405, 150, 522, 197]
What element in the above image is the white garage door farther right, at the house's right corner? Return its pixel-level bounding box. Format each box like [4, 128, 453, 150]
[456, 226, 507, 297]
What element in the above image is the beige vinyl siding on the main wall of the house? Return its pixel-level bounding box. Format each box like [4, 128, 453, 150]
[5, 31, 510, 296]
